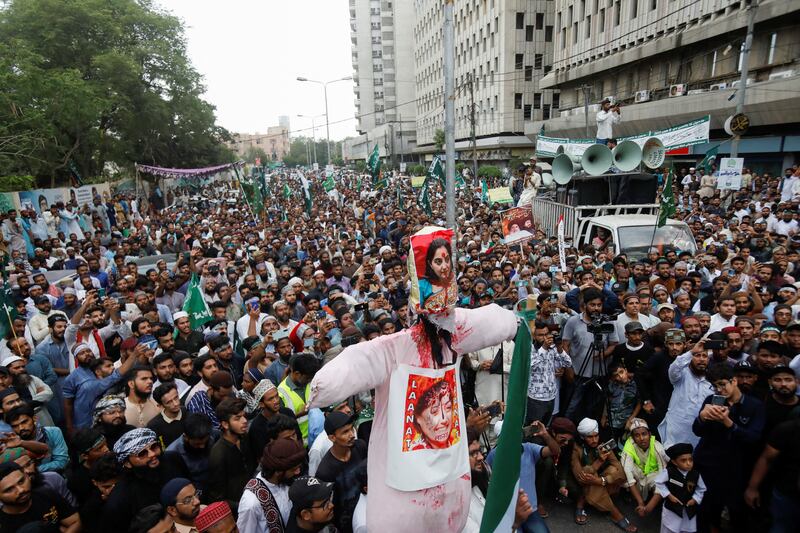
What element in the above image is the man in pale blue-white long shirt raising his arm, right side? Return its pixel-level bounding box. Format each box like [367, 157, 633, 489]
[658, 340, 714, 449]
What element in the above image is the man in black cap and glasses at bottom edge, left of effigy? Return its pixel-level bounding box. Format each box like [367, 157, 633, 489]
[285, 477, 335, 533]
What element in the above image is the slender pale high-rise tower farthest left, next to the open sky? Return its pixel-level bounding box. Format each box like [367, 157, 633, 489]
[343, 0, 416, 163]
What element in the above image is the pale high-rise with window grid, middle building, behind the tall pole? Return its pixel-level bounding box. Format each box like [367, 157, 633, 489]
[409, 0, 558, 164]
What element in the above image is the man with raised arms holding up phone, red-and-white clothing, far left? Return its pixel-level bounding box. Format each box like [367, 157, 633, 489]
[64, 290, 132, 357]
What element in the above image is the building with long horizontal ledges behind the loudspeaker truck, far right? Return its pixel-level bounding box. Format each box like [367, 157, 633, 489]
[525, 0, 800, 171]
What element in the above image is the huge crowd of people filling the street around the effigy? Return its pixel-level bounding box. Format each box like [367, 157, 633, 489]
[0, 160, 800, 533]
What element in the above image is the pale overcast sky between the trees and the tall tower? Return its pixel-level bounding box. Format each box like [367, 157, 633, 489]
[157, 0, 356, 139]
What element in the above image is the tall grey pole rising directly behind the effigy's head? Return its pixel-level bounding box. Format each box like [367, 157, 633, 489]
[443, 0, 457, 233]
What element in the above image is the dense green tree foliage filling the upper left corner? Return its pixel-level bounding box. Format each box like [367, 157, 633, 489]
[0, 0, 234, 186]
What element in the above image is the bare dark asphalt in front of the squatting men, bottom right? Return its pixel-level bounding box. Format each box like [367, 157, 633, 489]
[545, 495, 661, 533]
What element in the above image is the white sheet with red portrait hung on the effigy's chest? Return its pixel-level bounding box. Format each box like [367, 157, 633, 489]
[386, 357, 469, 491]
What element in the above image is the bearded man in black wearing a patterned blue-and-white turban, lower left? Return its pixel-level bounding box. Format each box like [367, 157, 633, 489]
[102, 428, 167, 531]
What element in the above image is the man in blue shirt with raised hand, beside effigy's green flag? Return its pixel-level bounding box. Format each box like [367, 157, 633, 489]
[486, 420, 561, 533]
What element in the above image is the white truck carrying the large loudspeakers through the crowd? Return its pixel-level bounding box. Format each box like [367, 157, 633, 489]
[533, 198, 697, 259]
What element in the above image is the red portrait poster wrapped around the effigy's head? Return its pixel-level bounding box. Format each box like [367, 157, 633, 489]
[408, 226, 458, 314]
